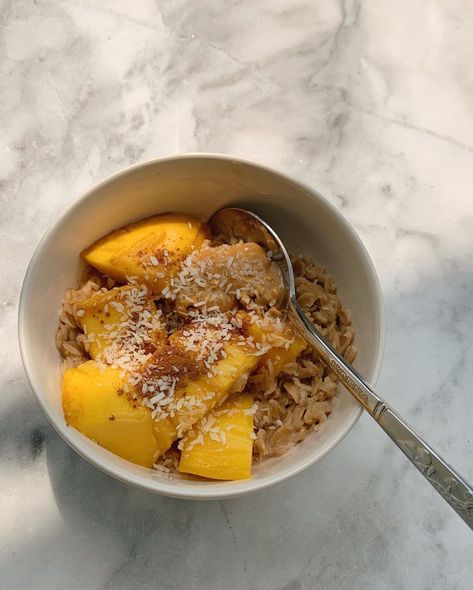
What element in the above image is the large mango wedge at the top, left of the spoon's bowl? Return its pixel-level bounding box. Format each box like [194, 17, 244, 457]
[81, 213, 210, 293]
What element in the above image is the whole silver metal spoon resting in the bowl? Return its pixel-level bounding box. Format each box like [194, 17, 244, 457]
[209, 207, 473, 528]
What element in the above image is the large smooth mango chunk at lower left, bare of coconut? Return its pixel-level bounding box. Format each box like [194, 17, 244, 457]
[62, 361, 158, 467]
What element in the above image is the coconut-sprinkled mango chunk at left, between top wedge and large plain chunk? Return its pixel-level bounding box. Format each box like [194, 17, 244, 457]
[76, 285, 162, 364]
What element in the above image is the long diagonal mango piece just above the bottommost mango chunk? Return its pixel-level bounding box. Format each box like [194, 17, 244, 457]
[140, 343, 259, 462]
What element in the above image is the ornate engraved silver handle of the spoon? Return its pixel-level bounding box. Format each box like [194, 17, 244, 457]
[289, 298, 473, 529]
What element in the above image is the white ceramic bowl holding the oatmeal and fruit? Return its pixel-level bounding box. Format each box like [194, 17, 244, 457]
[19, 154, 384, 499]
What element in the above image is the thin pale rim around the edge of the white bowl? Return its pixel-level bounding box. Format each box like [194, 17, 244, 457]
[18, 152, 386, 500]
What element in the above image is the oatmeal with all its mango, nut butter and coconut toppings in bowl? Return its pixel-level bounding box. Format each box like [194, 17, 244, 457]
[56, 214, 356, 479]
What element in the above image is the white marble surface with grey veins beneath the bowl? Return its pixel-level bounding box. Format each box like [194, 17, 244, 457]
[0, 0, 473, 590]
